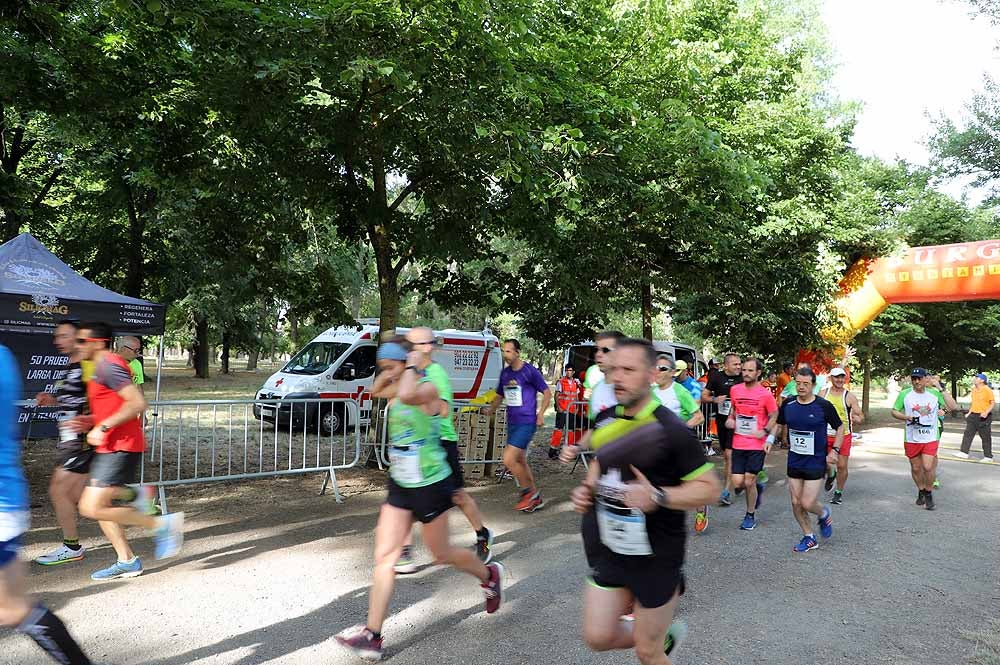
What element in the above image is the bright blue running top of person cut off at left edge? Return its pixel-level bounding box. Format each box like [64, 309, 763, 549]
[0, 344, 28, 513]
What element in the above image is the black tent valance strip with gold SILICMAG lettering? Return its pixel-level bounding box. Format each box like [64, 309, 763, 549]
[0, 293, 165, 335]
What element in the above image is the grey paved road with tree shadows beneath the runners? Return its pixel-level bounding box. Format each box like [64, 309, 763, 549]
[0, 431, 1000, 665]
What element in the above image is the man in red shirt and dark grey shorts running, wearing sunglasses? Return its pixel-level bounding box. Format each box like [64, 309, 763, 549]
[76, 323, 184, 581]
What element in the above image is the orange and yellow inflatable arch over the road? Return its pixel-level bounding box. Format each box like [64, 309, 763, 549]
[824, 240, 1000, 344]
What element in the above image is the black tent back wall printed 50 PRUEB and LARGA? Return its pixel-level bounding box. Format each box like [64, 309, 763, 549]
[0, 333, 60, 439]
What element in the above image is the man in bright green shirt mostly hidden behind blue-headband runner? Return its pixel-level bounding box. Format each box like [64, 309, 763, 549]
[372, 328, 493, 574]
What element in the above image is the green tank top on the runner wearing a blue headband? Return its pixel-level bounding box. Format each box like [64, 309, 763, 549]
[389, 399, 451, 488]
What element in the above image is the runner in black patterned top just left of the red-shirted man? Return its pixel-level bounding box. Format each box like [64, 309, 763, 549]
[35, 321, 94, 566]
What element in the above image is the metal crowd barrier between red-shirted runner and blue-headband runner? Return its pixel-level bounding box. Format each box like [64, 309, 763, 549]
[140, 399, 360, 511]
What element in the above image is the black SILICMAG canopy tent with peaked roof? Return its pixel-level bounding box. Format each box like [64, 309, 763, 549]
[0, 233, 166, 436]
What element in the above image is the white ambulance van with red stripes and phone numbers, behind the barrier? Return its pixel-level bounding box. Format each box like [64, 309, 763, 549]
[254, 321, 503, 435]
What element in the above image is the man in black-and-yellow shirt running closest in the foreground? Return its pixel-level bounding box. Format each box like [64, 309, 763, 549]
[563, 339, 720, 665]
